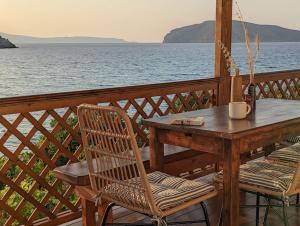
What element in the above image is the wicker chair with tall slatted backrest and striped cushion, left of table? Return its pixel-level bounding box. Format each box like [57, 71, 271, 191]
[78, 105, 217, 225]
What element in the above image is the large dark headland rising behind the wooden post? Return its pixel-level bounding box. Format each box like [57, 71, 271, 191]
[163, 21, 300, 43]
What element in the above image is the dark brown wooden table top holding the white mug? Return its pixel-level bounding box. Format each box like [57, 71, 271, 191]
[142, 99, 300, 139]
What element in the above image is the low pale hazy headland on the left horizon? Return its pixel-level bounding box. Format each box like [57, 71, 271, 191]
[0, 32, 127, 44]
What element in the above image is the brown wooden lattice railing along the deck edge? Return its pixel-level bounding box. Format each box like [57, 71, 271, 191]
[0, 71, 300, 225]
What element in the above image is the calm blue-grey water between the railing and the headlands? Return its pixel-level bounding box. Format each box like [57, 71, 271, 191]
[0, 43, 300, 98]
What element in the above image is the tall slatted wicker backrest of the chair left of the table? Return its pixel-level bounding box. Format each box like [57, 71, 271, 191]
[78, 105, 156, 213]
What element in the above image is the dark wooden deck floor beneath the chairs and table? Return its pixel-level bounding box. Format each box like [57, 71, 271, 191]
[59, 193, 300, 226]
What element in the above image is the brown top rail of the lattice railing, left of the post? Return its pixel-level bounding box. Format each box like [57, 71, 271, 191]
[0, 78, 219, 114]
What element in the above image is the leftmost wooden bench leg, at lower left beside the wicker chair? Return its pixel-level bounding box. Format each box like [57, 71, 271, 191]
[81, 197, 96, 226]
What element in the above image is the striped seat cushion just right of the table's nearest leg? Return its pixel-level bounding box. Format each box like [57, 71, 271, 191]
[216, 160, 296, 193]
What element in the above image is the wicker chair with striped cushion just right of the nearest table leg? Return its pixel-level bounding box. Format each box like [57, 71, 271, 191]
[215, 159, 300, 226]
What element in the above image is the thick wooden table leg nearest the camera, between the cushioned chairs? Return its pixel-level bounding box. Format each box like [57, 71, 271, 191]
[223, 140, 240, 226]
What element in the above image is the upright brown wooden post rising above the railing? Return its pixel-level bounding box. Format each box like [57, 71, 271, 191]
[215, 0, 232, 105]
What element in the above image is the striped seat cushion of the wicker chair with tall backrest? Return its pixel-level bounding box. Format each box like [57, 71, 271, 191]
[106, 172, 215, 210]
